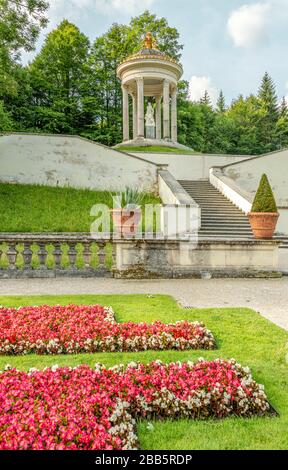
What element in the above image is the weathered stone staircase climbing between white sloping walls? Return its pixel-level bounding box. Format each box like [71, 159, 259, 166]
[179, 180, 253, 240]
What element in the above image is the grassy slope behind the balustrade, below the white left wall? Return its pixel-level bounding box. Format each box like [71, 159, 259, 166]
[0, 184, 159, 232]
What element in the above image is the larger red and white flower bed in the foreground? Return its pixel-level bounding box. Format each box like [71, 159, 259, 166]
[0, 360, 270, 450]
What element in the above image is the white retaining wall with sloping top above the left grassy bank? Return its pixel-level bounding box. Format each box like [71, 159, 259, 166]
[0, 134, 158, 191]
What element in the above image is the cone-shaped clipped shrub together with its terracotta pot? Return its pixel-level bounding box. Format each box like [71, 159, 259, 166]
[248, 174, 279, 239]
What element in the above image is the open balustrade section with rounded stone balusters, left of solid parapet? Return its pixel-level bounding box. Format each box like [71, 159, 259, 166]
[0, 233, 115, 278]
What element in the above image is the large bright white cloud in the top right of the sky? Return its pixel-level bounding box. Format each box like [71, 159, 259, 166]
[227, 3, 270, 48]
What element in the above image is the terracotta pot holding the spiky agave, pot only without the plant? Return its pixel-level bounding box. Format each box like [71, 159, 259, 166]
[110, 208, 142, 238]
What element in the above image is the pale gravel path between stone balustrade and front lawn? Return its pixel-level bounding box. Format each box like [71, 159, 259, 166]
[0, 277, 288, 330]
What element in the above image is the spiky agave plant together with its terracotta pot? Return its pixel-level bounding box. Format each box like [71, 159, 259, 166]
[110, 188, 144, 238]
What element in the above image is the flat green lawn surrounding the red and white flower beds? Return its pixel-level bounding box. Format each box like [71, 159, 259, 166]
[0, 295, 288, 450]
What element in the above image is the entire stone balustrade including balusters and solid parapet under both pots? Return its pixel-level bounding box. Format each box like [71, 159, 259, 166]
[0, 233, 281, 279]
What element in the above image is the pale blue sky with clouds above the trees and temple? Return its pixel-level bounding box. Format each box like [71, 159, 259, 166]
[24, 0, 288, 106]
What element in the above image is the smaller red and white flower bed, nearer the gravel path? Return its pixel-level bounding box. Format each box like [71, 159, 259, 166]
[0, 305, 216, 355]
